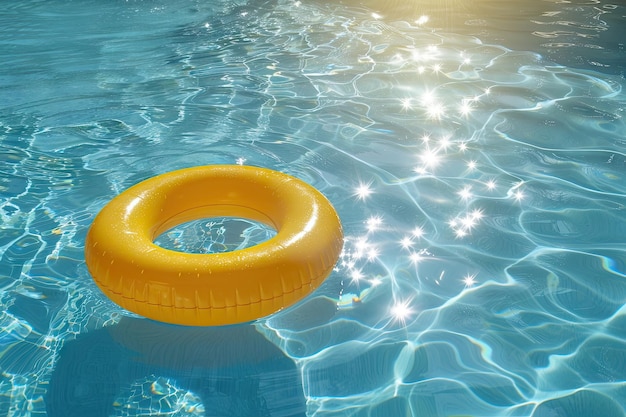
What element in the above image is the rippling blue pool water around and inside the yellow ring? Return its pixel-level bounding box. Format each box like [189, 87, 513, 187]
[0, 0, 626, 417]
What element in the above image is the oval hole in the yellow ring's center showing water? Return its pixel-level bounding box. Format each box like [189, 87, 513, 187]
[154, 217, 276, 253]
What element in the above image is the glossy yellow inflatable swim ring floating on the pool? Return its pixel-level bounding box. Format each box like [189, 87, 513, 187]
[85, 165, 343, 326]
